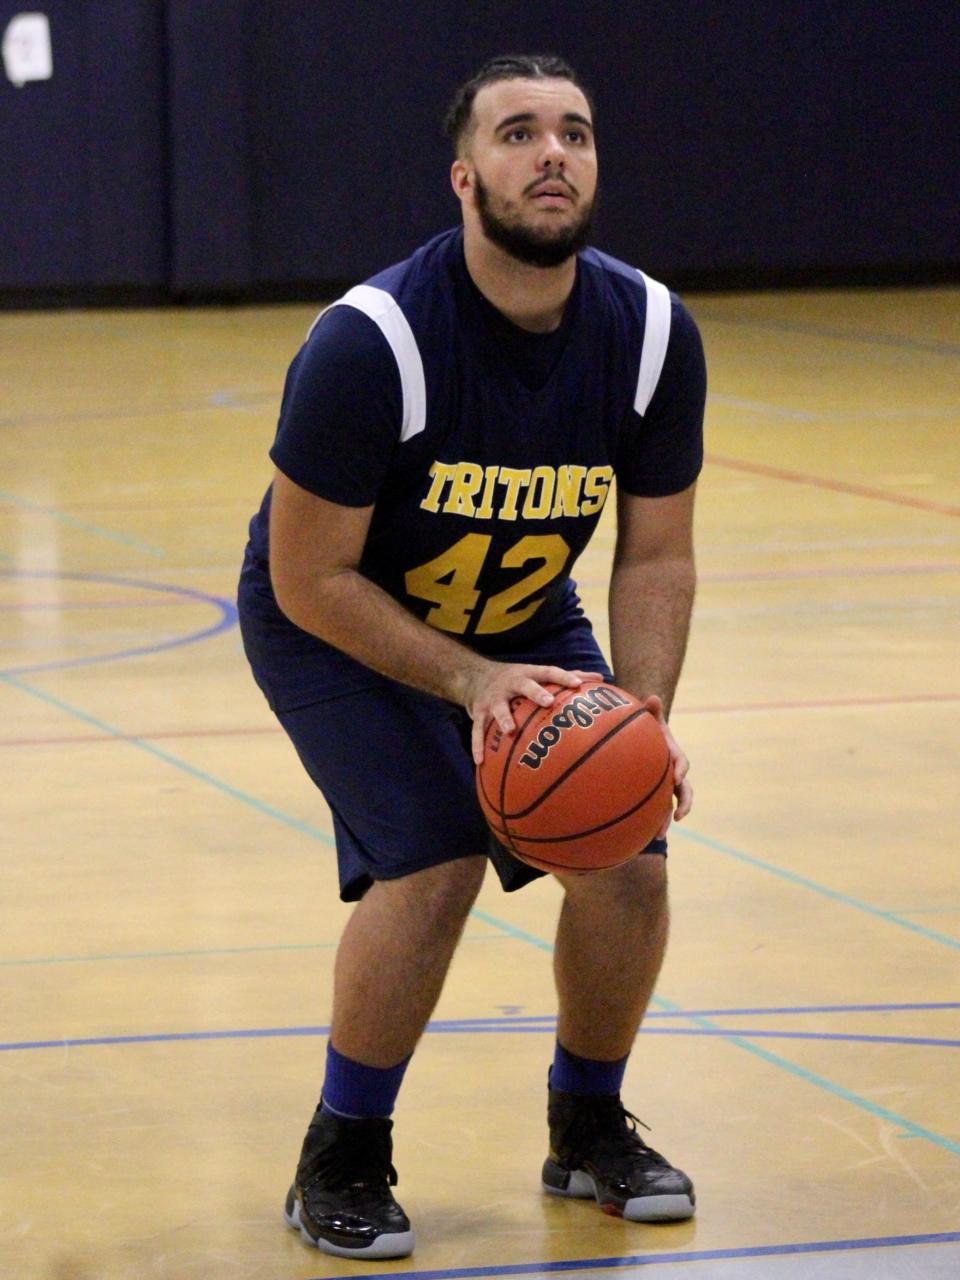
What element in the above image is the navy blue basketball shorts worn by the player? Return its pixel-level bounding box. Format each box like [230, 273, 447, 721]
[241, 570, 667, 902]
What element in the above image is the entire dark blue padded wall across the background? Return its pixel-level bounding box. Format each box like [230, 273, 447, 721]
[0, 0, 960, 297]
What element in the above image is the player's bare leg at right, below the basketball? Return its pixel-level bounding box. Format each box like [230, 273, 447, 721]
[553, 854, 669, 1062]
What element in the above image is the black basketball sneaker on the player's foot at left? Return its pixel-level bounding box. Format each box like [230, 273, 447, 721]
[283, 1110, 413, 1258]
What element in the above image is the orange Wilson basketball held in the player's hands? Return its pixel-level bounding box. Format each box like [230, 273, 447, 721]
[476, 676, 673, 872]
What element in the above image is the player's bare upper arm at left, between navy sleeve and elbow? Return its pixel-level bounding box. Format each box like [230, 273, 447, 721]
[270, 471, 374, 622]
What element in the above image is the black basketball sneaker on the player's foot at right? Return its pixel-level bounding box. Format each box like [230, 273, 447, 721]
[543, 1089, 696, 1222]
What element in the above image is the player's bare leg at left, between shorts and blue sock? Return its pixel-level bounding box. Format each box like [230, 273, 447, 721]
[330, 858, 486, 1068]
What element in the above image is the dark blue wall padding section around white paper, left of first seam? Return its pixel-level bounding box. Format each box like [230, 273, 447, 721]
[0, 0, 168, 288]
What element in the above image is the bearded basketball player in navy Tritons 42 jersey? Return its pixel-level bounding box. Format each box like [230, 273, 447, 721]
[239, 58, 705, 1260]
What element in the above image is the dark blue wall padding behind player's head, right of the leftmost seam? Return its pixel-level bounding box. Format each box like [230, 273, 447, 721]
[163, 0, 960, 289]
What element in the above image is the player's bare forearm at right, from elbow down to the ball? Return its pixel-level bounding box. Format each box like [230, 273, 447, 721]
[609, 556, 696, 716]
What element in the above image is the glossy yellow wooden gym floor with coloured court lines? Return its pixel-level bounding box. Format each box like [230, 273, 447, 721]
[0, 288, 960, 1280]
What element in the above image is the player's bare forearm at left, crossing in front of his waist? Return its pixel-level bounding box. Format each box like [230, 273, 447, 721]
[279, 568, 494, 704]
